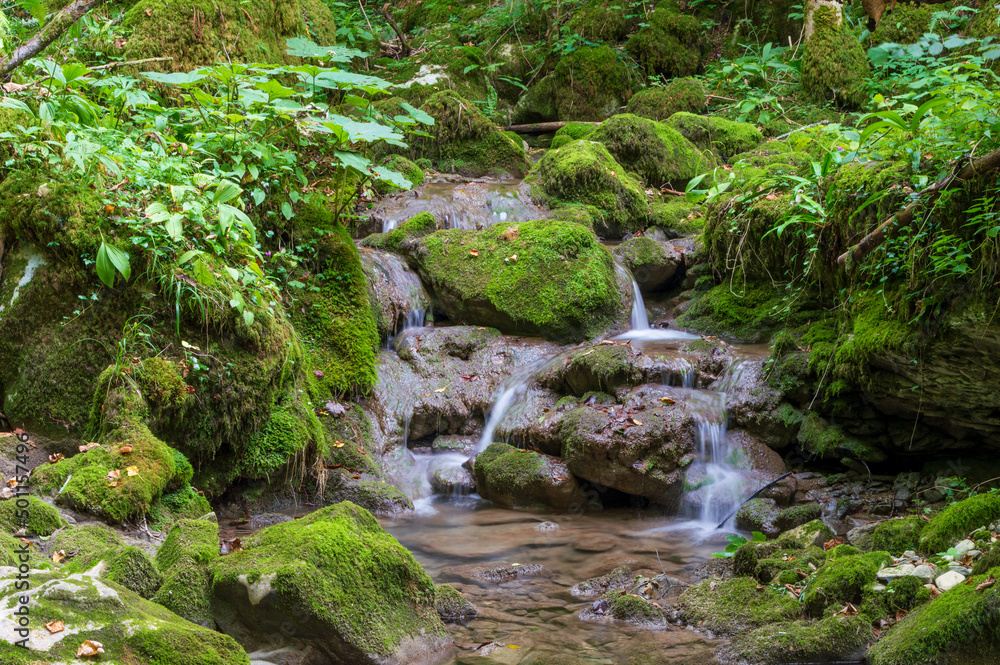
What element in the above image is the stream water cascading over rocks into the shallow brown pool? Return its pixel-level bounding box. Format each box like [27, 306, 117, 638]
[356, 174, 759, 664]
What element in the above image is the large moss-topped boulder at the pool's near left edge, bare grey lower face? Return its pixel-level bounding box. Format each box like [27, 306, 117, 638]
[212, 501, 451, 665]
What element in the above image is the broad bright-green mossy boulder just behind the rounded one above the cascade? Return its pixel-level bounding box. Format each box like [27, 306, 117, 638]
[590, 113, 715, 189]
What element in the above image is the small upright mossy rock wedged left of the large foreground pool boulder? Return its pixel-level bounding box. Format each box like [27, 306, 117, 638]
[153, 519, 219, 626]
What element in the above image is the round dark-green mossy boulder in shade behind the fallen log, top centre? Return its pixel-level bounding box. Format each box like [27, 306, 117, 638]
[543, 46, 636, 120]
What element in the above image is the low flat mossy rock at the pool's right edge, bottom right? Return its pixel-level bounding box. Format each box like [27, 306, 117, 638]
[678, 577, 799, 636]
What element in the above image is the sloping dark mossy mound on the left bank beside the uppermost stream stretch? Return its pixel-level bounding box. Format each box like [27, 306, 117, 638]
[411, 90, 531, 178]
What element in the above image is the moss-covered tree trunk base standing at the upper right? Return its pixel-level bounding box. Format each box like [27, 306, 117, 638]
[801, 6, 871, 108]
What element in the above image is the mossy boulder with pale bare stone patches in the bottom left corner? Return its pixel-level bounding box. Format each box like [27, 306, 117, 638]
[0, 569, 250, 665]
